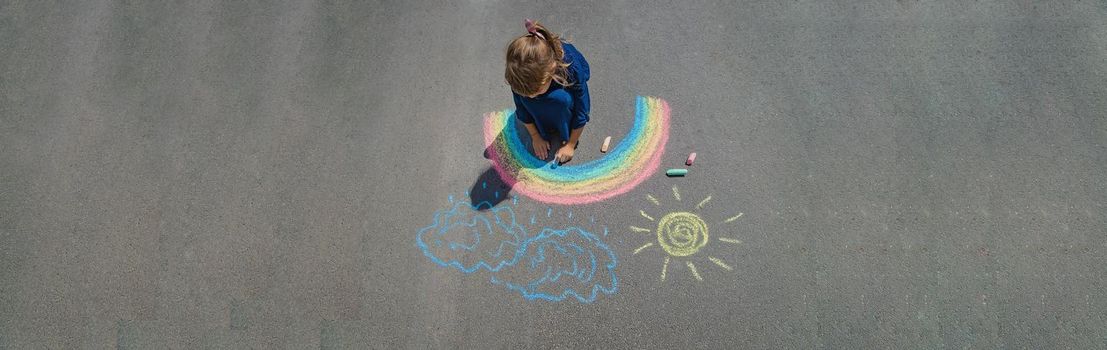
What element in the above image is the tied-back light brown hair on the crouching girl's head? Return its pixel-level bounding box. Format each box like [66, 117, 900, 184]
[504, 20, 571, 96]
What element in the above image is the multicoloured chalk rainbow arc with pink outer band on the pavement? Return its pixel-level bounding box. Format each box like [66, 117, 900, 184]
[484, 96, 670, 205]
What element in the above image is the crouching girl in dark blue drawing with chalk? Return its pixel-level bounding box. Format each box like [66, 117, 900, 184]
[504, 19, 591, 163]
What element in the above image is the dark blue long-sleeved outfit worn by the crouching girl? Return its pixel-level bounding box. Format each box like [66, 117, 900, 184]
[511, 42, 591, 141]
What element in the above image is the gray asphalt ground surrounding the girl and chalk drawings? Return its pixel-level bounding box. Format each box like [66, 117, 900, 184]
[0, 0, 1107, 349]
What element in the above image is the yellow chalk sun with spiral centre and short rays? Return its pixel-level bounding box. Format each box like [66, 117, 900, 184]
[630, 186, 742, 281]
